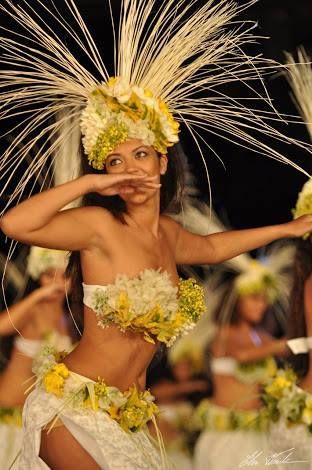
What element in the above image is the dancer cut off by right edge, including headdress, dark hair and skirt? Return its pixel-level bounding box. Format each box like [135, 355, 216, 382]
[264, 49, 312, 470]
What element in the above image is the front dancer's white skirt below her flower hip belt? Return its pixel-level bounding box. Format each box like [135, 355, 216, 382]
[13, 387, 163, 470]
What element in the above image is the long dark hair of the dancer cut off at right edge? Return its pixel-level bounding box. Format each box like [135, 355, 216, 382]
[287, 236, 312, 376]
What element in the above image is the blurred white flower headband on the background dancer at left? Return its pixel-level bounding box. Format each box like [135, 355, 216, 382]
[27, 246, 68, 281]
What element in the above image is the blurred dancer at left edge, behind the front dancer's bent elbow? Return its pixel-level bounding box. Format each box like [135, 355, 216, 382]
[0, 247, 71, 470]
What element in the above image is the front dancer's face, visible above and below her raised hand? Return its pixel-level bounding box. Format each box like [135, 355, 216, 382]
[105, 139, 168, 204]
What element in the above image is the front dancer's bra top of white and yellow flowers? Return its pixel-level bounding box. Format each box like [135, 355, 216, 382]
[83, 269, 206, 346]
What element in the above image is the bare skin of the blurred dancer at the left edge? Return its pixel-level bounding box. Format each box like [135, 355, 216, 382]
[0, 269, 69, 407]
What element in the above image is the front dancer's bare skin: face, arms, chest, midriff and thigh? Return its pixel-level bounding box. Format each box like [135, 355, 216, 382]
[1, 139, 312, 470]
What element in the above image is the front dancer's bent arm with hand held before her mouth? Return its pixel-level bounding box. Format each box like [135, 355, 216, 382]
[1, 174, 159, 251]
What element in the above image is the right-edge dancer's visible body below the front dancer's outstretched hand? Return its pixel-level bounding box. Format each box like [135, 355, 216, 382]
[264, 238, 312, 470]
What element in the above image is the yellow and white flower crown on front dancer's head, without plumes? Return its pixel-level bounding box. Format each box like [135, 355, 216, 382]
[80, 77, 179, 170]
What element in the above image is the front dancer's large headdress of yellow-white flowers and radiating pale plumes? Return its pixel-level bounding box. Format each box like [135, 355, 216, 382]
[0, 0, 312, 215]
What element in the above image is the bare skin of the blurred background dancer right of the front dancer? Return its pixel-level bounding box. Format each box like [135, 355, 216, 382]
[211, 294, 287, 410]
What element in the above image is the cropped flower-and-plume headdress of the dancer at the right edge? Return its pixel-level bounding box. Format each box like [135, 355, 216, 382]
[286, 48, 312, 219]
